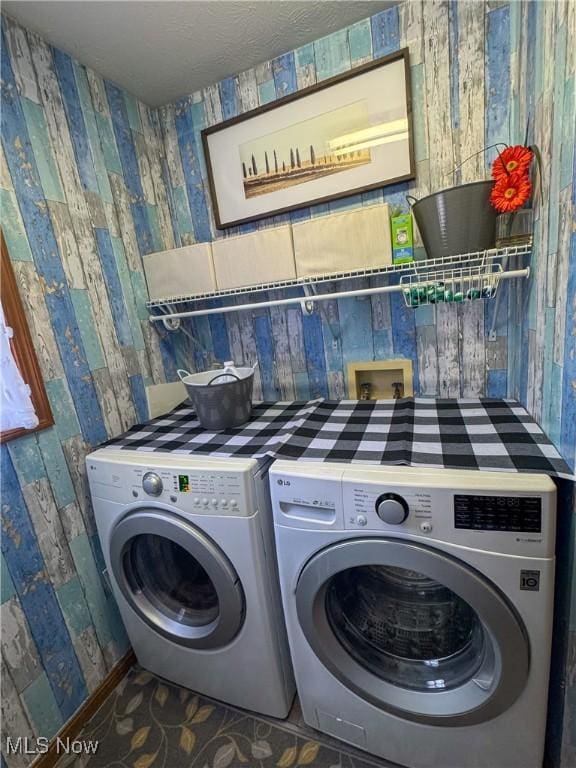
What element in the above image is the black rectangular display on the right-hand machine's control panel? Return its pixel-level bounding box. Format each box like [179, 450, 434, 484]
[454, 494, 542, 533]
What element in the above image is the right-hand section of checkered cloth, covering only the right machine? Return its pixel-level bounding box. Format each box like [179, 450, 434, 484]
[276, 398, 572, 477]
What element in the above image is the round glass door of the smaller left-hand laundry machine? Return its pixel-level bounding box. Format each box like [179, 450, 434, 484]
[110, 509, 244, 648]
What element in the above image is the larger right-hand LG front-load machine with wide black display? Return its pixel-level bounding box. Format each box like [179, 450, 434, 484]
[270, 461, 556, 768]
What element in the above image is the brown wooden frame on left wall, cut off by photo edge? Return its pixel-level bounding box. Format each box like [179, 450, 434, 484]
[0, 232, 54, 443]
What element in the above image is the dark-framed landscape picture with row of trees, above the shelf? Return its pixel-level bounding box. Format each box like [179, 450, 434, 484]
[202, 48, 414, 229]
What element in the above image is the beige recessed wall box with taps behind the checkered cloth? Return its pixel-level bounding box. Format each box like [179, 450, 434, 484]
[348, 359, 414, 400]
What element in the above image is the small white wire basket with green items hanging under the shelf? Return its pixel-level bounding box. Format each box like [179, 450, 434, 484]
[400, 262, 503, 309]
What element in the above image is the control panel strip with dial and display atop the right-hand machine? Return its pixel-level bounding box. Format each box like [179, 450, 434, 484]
[270, 460, 556, 558]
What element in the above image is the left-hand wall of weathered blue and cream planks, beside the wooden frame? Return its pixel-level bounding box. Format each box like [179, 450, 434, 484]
[0, 17, 174, 765]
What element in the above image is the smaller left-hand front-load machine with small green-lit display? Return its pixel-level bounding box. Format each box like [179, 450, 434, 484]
[86, 448, 295, 717]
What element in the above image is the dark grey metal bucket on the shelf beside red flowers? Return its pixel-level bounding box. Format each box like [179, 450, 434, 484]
[406, 181, 496, 259]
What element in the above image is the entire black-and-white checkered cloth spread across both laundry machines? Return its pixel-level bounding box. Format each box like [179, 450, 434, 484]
[108, 397, 574, 479]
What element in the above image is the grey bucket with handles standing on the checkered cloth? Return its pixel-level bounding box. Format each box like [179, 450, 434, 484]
[178, 368, 254, 430]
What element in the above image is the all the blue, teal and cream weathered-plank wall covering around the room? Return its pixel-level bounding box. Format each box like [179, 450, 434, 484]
[0, 1, 576, 768]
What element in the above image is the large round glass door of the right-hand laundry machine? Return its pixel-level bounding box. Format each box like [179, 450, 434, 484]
[296, 539, 529, 725]
